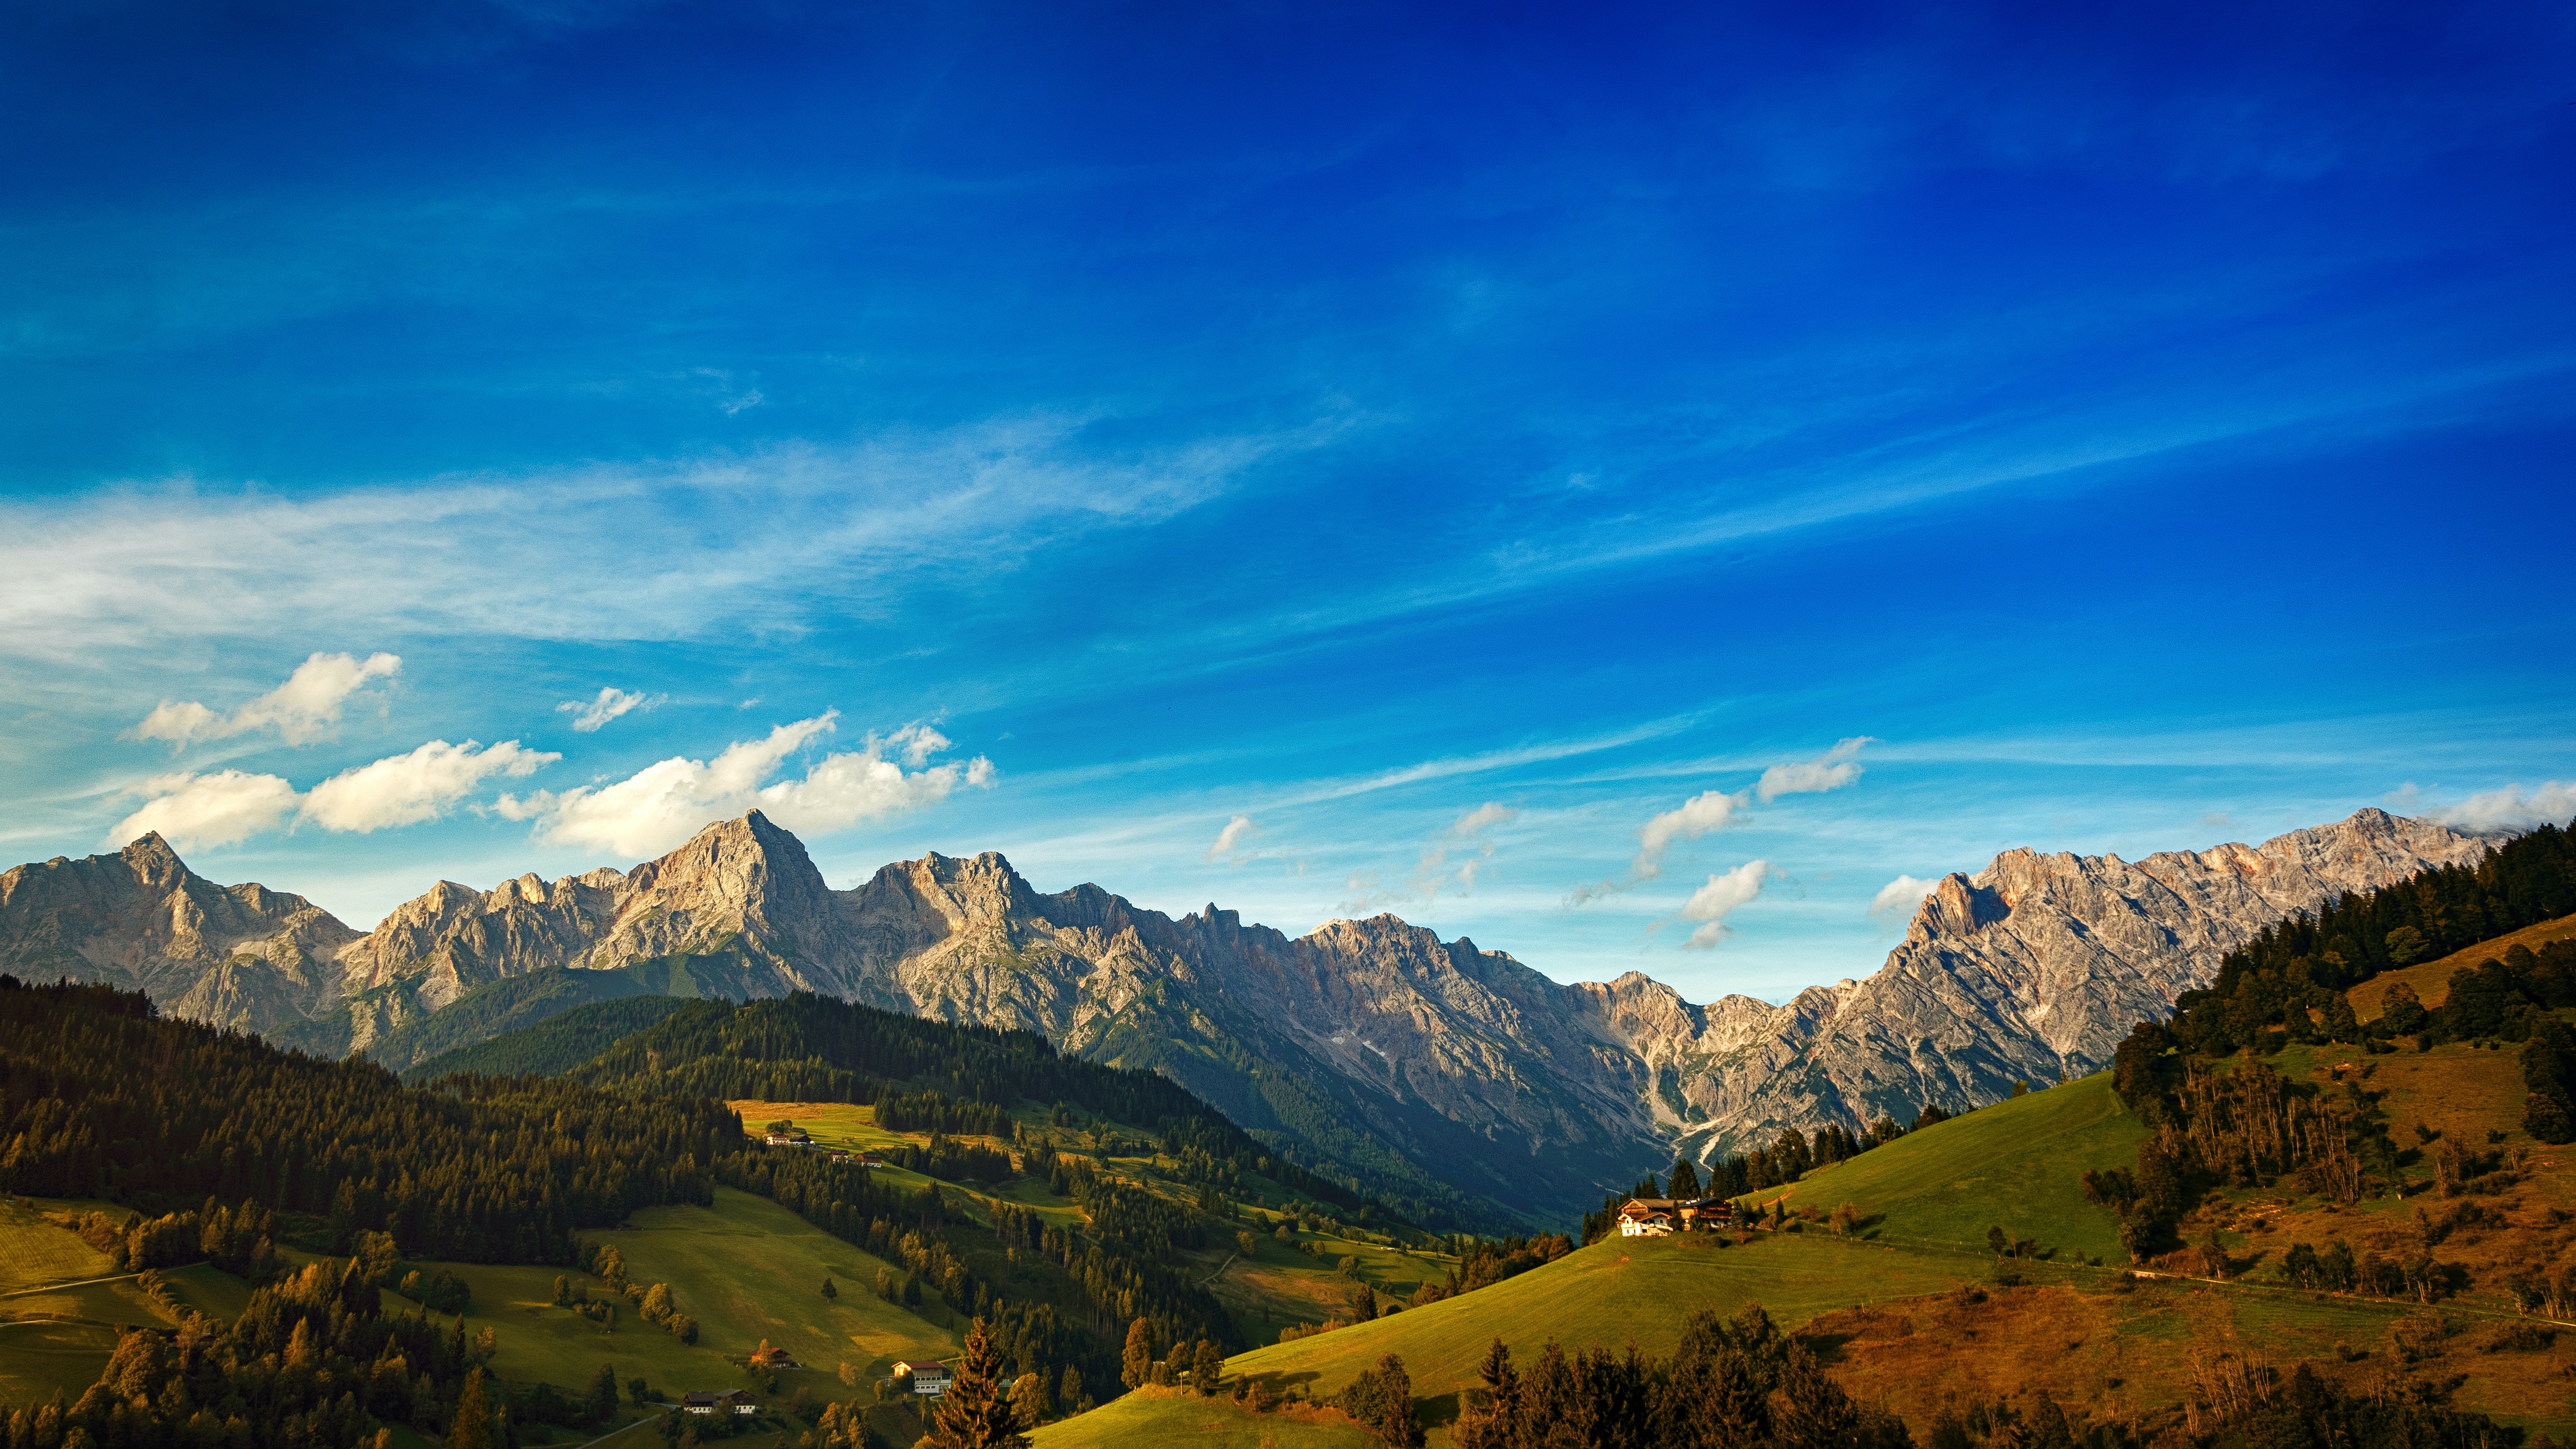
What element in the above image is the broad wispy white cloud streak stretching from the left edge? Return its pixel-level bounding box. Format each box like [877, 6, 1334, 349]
[0, 415, 1342, 665]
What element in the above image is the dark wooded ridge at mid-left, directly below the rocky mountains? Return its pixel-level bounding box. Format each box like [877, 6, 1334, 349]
[567, 993, 1383, 1215]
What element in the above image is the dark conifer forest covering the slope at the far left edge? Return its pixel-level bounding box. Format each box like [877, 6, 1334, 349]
[0, 975, 742, 1263]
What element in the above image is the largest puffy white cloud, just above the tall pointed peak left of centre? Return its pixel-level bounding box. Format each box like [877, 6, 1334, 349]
[497, 709, 994, 856]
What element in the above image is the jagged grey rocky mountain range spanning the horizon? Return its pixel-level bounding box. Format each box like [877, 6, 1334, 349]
[0, 809, 2488, 1222]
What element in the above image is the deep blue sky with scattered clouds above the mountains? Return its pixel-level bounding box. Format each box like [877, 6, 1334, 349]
[0, 0, 2576, 1001]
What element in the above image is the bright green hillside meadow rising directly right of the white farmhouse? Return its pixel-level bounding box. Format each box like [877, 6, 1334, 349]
[1747, 1073, 2146, 1263]
